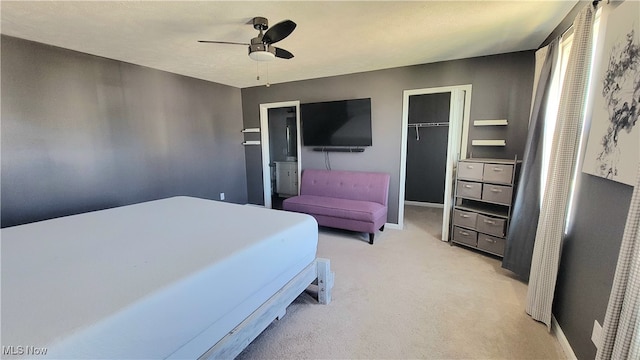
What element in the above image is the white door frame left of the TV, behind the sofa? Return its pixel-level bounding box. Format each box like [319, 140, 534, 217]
[260, 100, 302, 209]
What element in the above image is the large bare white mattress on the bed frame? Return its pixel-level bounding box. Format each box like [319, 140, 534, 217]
[0, 197, 318, 359]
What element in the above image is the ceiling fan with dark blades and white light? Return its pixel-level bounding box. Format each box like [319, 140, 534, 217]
[198, 17, 296, 61]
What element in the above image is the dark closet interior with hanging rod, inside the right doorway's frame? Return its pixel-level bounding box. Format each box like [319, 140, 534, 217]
[405, 92, 451, 204]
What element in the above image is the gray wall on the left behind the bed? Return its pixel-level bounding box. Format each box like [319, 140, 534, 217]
[1, 36, 247, 227]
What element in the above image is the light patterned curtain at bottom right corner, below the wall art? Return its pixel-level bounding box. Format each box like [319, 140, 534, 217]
[596, 166, 640, 360]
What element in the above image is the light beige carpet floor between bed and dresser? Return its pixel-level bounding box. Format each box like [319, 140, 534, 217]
[238, 206, 565, 359]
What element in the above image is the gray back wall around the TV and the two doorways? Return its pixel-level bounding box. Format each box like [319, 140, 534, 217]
[242, 51, 534, 223]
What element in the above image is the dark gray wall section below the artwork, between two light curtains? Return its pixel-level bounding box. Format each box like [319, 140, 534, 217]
[553, 173, 633, 359]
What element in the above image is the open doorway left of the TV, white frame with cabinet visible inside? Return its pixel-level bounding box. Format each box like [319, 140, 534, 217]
[260, 101, 301, 209]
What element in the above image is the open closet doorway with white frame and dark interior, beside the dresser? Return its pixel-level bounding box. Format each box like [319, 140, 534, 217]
[398, 85, 471, 241]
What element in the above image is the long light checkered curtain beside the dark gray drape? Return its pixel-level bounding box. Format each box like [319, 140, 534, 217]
[526, 6, 595, 329]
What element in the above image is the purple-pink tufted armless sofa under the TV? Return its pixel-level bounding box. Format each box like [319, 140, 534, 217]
[283, 169, 389, 244]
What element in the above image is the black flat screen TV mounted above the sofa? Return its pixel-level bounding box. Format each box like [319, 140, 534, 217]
[300, 98, 371, 147]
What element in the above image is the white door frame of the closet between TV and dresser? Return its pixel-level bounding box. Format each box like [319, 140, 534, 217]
[398, 84, 472, 241]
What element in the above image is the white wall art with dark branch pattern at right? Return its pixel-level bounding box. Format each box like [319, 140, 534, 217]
[582, 1, 640, 185]
